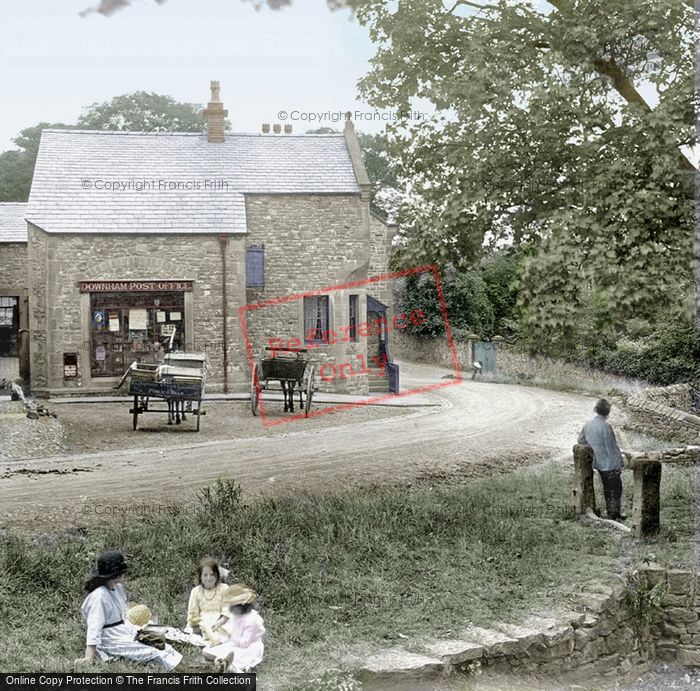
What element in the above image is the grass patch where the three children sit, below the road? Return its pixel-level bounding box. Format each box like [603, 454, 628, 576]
[0, 456, 693, 688]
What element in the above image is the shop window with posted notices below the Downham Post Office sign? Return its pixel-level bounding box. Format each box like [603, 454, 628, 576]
[90, 292, 185, 377]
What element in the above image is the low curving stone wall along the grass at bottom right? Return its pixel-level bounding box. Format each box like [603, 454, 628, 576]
[359, 564, 700, 683]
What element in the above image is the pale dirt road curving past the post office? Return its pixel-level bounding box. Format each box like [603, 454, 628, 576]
[0, 365, 600, 530]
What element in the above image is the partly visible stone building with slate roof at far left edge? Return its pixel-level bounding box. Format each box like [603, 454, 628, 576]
[0, 202, 27, 357]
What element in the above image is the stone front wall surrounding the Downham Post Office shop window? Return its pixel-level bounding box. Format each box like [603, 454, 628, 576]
[28, 225, 248, 393]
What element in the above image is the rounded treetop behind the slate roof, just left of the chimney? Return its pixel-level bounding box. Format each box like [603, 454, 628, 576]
[78, 91, 204, 132]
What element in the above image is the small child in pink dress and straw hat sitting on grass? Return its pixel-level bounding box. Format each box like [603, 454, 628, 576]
[202, 583, 265, 672]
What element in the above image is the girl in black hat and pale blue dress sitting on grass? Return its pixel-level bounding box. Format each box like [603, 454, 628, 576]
[76, 550, 182, 672]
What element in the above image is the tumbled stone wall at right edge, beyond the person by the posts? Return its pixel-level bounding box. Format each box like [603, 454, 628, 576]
[626, 384, 700, 444]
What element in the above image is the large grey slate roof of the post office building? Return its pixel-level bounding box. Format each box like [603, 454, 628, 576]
[26, 129, 360, 233]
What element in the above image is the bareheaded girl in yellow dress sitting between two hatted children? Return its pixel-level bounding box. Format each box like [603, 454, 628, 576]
[185, 558, 229, 645]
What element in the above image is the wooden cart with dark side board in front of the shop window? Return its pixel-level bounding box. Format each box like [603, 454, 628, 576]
[120, 353, 206, 432]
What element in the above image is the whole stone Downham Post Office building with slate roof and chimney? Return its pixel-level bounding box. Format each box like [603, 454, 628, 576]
[21, 82, 392, 395]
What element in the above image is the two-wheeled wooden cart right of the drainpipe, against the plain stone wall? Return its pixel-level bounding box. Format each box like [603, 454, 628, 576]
[250, 347, 318, 417]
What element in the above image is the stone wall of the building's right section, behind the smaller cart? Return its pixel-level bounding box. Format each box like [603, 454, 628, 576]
[246, 194, 370, 394]
